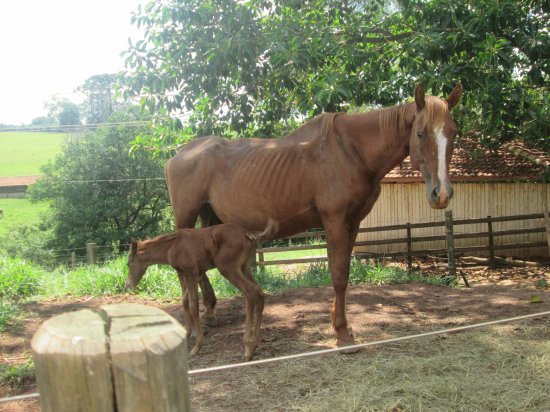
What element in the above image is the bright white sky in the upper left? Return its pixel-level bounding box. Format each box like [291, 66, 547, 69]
[0, 0, 145, 125]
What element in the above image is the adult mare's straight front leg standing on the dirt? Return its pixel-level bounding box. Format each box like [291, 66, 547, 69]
[325, 220, 355, 346]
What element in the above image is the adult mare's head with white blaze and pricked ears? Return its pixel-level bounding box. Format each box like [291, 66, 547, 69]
[410, 84, 462, 209]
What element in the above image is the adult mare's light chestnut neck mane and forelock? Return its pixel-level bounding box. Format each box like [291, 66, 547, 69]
[379, 96, 449, 146]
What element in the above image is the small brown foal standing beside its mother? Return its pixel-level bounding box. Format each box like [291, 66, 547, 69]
[126, 223, 265, 361]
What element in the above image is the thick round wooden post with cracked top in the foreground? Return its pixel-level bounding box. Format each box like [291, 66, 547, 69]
[31, 304, 190, 412]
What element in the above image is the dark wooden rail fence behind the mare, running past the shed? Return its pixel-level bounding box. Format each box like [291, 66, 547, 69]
[256, 213, 550, 266]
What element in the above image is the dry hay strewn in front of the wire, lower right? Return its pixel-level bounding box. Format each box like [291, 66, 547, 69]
[191, 317, 550, 411]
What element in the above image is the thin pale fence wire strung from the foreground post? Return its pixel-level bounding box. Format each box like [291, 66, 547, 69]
[0, 311, 550, 403]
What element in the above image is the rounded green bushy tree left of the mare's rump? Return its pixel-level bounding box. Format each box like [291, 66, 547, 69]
[29, 109, 169, 248]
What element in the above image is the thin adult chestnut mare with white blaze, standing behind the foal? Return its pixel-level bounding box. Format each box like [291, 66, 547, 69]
[166, 85, 462, 346]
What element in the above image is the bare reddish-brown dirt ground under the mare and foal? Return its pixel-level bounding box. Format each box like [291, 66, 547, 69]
[0, 266, 550, 412]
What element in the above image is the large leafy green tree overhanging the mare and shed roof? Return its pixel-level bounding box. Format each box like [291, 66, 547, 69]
[123, 0, 550, 151]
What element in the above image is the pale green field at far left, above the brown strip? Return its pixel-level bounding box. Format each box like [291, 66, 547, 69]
[0, 132, 66, 177]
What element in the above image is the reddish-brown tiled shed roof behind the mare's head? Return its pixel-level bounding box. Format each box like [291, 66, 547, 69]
[383, 137, 550, 183]
